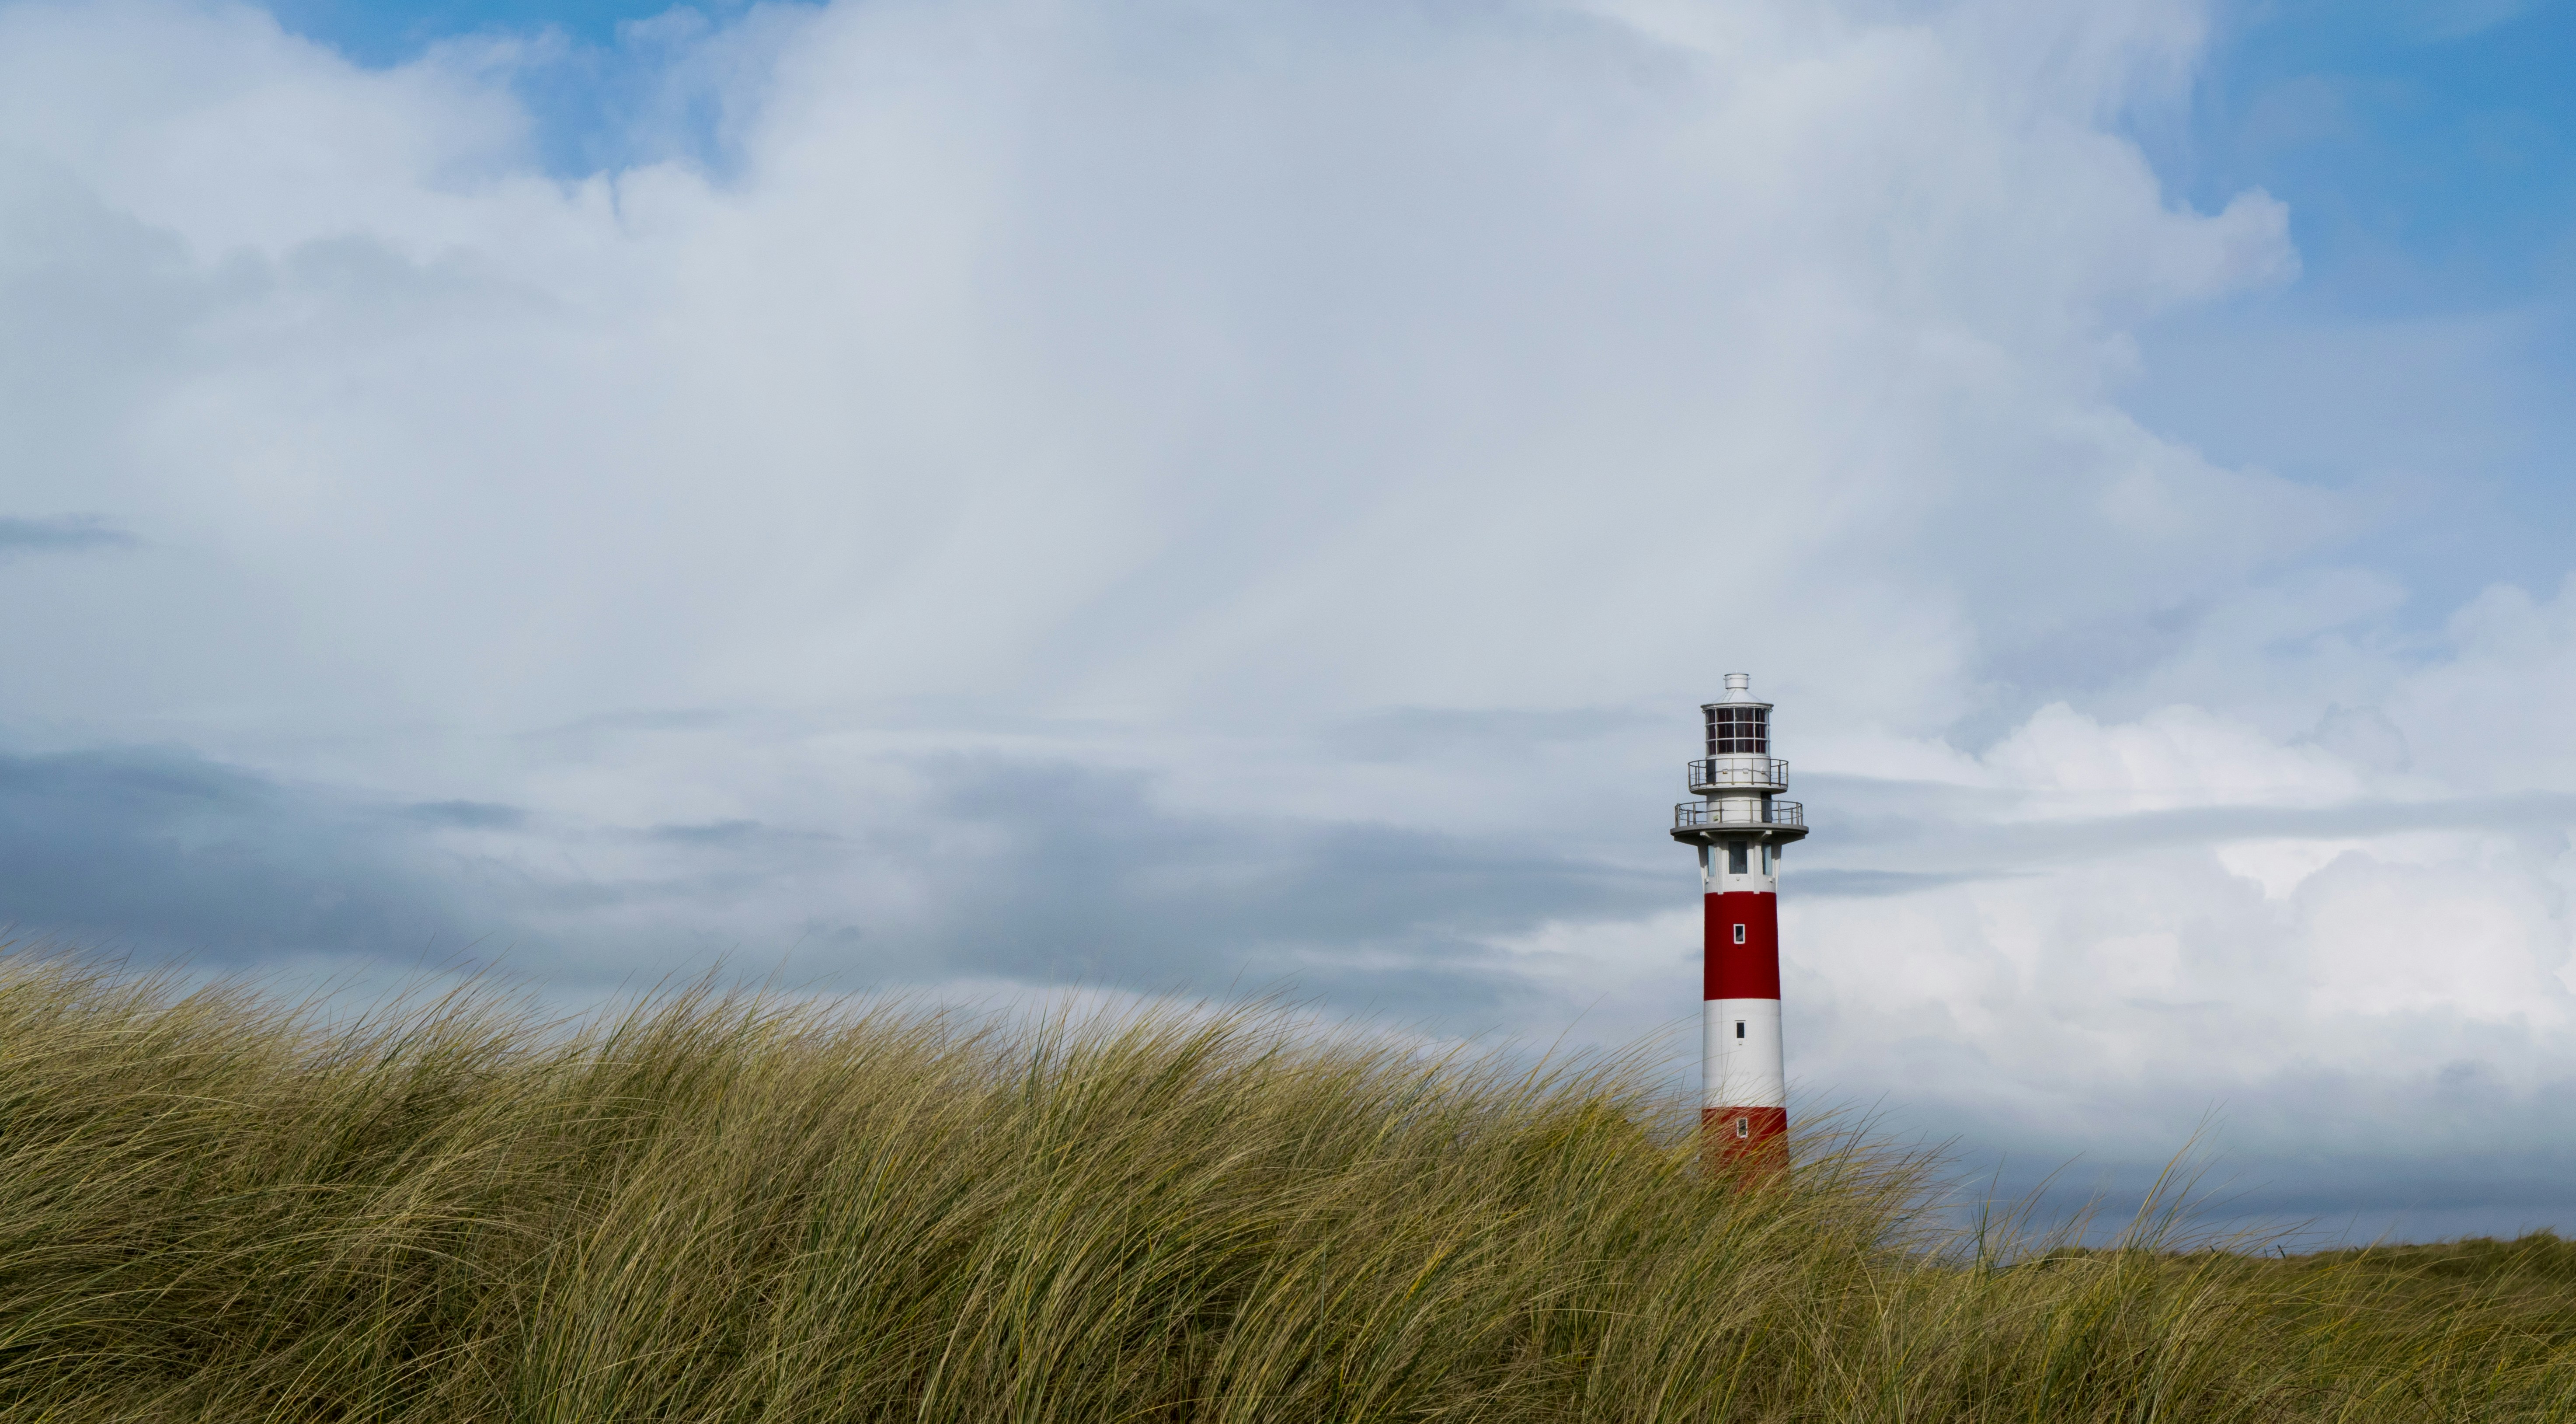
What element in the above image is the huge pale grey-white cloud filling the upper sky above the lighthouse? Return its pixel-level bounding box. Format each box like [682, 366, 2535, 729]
[0, 5, 2334, 726]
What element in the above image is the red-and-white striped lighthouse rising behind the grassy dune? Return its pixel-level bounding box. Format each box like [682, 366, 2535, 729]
[1672, 672, 1806, 1169]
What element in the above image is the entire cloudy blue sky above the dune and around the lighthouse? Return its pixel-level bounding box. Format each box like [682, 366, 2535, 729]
[0, 0, 2576, 1239]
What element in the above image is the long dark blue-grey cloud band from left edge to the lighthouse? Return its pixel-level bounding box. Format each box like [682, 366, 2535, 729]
[0, 749, 1672, 1027]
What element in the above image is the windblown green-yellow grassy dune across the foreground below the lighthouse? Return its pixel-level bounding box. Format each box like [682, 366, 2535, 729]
[0, 960, 2576, 1424]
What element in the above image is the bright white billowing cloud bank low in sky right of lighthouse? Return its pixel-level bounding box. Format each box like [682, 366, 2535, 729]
[1785, 680, 2576, 1236]
